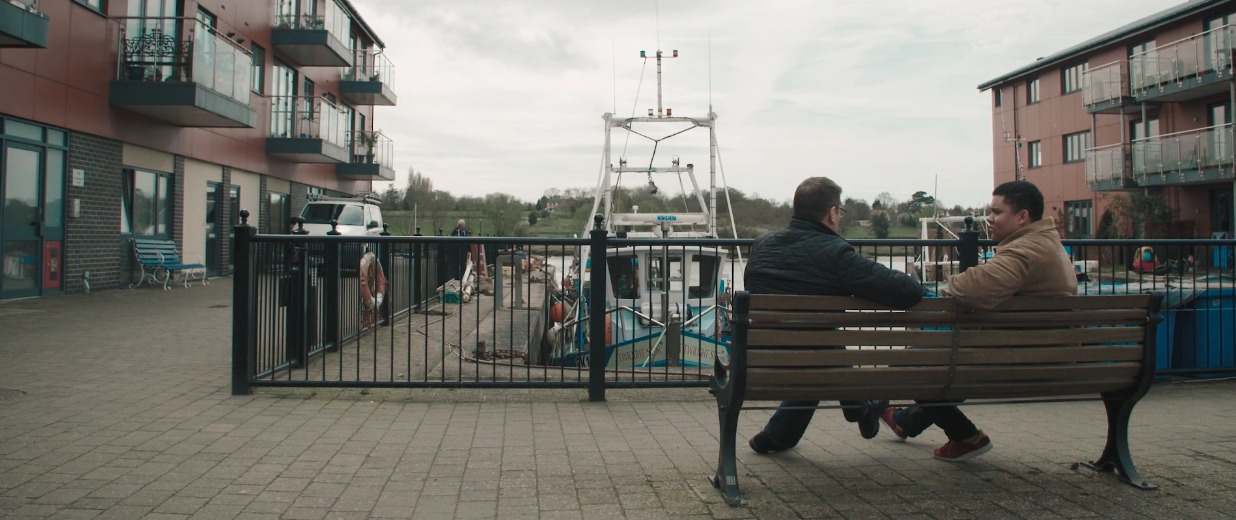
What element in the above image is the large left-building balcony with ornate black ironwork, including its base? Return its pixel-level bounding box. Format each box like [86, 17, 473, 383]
[109, 19, 257, 128]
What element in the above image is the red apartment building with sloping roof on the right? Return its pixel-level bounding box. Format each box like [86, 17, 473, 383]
[979, 0, 1236, 243]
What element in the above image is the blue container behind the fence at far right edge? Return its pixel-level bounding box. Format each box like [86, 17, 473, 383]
[1175, 289, 1236, 377]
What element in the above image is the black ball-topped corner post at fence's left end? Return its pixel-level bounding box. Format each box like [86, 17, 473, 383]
[232, 210, 257, 395]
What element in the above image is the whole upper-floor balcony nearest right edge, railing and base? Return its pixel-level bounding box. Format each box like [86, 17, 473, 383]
[1128, 26, 1234, 103]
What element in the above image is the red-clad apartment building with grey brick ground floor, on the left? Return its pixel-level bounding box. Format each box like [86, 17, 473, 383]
[0, 0, 396, 299]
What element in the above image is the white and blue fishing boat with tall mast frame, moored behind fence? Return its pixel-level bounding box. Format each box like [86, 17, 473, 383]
[551, 51, 740, 372]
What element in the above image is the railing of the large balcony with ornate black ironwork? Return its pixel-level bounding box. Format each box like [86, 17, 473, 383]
[116, 17, 253, 105]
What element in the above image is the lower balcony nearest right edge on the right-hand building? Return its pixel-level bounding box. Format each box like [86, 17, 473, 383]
[1132, 124, 1236, 187]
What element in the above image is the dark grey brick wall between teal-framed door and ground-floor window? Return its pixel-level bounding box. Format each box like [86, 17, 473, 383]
[64, 132, 122, 293]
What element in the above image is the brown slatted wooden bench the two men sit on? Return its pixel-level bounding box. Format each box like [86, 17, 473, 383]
[709, 291, 1161, 505]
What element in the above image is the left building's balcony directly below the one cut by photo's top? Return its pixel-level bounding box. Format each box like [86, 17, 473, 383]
[266, 95, 352, 164]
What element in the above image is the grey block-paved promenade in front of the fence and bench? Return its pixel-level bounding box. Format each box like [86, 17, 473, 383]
[0, 279, 1236, 520]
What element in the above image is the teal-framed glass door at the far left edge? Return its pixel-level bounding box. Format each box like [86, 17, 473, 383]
[0, 143, 43, 300]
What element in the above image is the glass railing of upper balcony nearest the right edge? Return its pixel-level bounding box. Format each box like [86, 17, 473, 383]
[1128, 26, 1234, 95]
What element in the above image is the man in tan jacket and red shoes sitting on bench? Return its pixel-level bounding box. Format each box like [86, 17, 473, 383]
[880, 180, 1078, 462]
